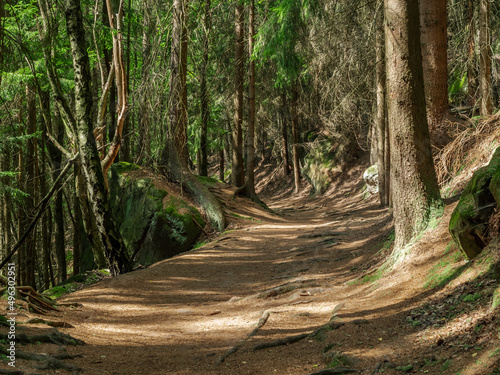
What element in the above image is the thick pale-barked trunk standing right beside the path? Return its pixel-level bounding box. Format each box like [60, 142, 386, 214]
[385, 0, 442, 249]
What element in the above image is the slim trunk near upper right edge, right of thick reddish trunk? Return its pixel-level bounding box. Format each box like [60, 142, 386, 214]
[479, 0, 493, 116]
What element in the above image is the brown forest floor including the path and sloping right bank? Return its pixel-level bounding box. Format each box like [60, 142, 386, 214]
[2, 160, 500, 375]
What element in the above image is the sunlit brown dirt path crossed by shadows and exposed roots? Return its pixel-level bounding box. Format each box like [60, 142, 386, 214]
[54, 184, 436, 375]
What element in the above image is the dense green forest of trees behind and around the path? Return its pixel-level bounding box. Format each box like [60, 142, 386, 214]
[0, 0, 500, 290]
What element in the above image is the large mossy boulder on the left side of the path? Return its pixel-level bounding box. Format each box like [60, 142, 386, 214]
[108, 162, 205, 265]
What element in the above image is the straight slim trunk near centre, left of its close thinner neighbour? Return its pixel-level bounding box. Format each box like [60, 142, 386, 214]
[231, 0, 245, 187]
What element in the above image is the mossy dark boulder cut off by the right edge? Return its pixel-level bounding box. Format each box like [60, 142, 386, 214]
[449, 147, 500, 259]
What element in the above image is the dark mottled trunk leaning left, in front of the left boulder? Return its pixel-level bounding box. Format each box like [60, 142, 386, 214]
[65, 0, 132, 276]
